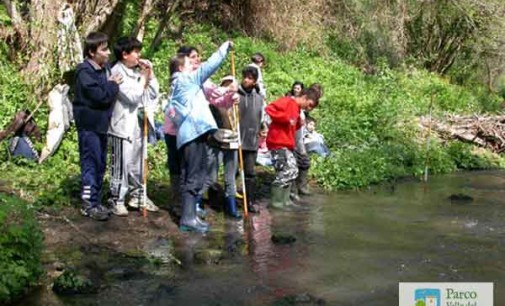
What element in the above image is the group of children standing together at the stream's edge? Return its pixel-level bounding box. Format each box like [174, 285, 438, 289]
[74, 32, 322, 232]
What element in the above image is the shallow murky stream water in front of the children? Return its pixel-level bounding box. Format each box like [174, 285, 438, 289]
[17, 171, 505, 305]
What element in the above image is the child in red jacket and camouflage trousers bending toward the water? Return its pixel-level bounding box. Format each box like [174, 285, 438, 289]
[265, 88, 319, 209]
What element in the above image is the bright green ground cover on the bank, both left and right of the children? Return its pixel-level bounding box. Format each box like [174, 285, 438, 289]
[0, 25, 504, 198]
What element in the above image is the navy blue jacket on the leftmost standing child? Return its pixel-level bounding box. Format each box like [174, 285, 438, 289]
[73, 60, 119, 134]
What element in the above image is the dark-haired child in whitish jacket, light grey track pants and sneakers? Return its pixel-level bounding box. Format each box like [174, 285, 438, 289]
[109, 37, 159, 216]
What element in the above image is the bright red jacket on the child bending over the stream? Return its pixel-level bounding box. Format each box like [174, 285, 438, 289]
[265, 97, 302, 151]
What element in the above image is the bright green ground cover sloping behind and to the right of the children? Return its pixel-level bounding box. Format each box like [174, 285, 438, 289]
[149, 25, 505, 189]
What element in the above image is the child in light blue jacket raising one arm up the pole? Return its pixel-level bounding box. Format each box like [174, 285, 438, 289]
[167, 41, 232, 233]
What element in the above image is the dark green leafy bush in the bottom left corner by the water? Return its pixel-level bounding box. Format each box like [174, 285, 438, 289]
[0, 193, 42, 303]
